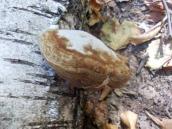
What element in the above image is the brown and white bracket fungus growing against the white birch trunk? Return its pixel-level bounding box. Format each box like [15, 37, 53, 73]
[40, 26, 131, 100]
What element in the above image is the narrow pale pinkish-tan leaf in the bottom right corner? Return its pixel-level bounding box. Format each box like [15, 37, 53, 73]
[146, 112, 172, 129]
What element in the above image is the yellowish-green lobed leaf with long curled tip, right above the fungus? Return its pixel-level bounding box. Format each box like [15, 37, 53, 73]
[101, 18, 164, 50]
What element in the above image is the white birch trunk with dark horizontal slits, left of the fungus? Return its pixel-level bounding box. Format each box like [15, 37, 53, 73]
[0, 0, 80, 129]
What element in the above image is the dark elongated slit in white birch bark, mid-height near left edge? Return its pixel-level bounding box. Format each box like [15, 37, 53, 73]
[3, 58, 36, 67]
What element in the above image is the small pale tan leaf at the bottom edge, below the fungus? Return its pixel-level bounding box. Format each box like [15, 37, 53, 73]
[120, 111, 138, 129]
